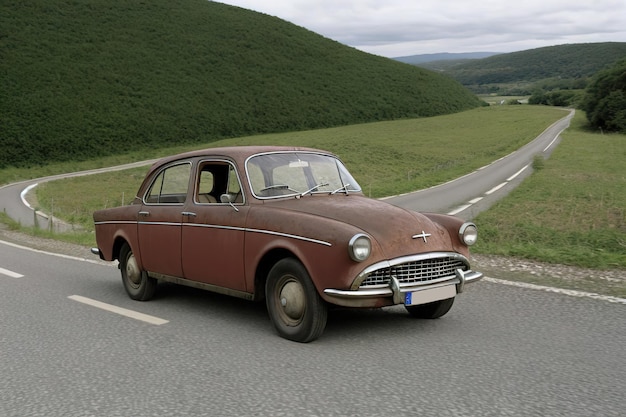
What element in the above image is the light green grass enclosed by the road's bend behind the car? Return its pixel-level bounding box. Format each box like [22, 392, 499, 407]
[25, 106, 565, 237]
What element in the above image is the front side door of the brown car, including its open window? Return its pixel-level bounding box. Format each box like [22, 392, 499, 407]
[182, 160, 249, 291]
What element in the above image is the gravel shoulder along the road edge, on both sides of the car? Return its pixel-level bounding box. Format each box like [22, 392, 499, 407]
[0, 224, 626, 298]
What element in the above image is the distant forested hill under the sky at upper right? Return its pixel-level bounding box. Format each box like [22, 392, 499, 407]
[422, 42, 626, 94]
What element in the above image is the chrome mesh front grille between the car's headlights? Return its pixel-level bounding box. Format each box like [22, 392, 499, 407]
[361, 257, 467, 287]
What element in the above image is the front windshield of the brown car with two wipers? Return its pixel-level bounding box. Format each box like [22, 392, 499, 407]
[246, 152, 361, 198]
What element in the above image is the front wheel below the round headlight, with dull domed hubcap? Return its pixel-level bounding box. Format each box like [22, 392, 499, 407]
[265, 258, 328, 343]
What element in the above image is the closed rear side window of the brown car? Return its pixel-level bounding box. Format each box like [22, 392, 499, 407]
[145, 163, 191, 204]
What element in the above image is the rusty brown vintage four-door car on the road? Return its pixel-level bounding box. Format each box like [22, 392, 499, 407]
[92, 147, 482, 342]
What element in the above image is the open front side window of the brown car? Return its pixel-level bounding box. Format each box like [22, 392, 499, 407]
[195, 161, 243, 204]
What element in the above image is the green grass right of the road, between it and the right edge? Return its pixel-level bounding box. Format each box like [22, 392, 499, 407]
[475, 112, 626, 269]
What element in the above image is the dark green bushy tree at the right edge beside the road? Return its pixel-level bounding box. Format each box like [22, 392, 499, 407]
[582, 59, 626, 133]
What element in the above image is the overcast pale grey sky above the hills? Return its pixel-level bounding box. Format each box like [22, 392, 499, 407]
[218, 0, 626, 58]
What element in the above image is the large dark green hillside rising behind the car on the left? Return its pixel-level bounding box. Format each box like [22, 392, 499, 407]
[0, 0, 480, 168]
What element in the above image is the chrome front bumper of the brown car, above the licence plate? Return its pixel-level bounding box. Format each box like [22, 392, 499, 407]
[324, 269, 483, 307]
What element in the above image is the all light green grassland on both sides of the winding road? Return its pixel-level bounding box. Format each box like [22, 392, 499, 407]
[0, 106, 626, 276]
